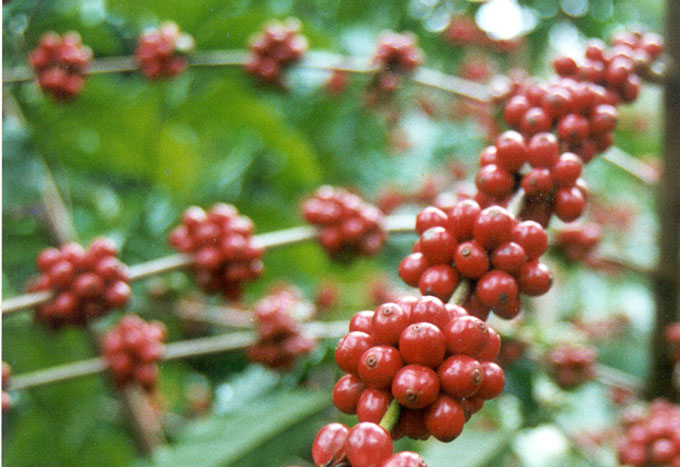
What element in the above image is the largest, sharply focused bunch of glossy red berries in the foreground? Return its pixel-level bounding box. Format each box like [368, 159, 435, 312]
[333, 296, 505, 446]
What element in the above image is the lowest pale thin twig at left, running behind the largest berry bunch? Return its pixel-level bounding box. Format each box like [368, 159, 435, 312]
[9, 321, 348, 391]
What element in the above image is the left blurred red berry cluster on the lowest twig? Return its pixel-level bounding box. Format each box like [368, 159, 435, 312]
[102, 315, 167, 391]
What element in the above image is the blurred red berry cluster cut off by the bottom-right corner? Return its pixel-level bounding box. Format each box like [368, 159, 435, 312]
[618, 399, 680, 467]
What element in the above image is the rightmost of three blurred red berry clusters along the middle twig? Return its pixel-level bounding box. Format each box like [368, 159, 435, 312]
[302, 186, 387, 260]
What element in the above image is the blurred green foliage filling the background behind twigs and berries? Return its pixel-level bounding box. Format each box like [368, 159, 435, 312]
[2, 0, 662, 466]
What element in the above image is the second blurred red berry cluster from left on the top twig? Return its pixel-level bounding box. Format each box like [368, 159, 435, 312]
[135, 22, 194, 79]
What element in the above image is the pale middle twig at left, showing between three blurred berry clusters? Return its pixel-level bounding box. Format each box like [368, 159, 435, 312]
[2, 216, 415, 316]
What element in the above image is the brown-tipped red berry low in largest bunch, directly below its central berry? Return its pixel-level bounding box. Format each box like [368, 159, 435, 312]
[392, 365, 440, 409]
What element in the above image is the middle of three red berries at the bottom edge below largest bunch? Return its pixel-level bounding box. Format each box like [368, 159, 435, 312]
[345, 422, 394, 467]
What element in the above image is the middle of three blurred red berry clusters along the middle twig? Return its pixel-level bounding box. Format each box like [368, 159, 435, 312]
[169, 203, 264, 300]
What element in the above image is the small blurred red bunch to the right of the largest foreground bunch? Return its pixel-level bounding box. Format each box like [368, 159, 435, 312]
[548, 345, 597, 389]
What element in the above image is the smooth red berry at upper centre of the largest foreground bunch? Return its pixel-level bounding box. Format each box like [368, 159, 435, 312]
[399, 323, 446, 368]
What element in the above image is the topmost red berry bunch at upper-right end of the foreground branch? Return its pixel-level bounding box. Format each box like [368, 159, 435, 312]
[553, 32, 663, 105]
